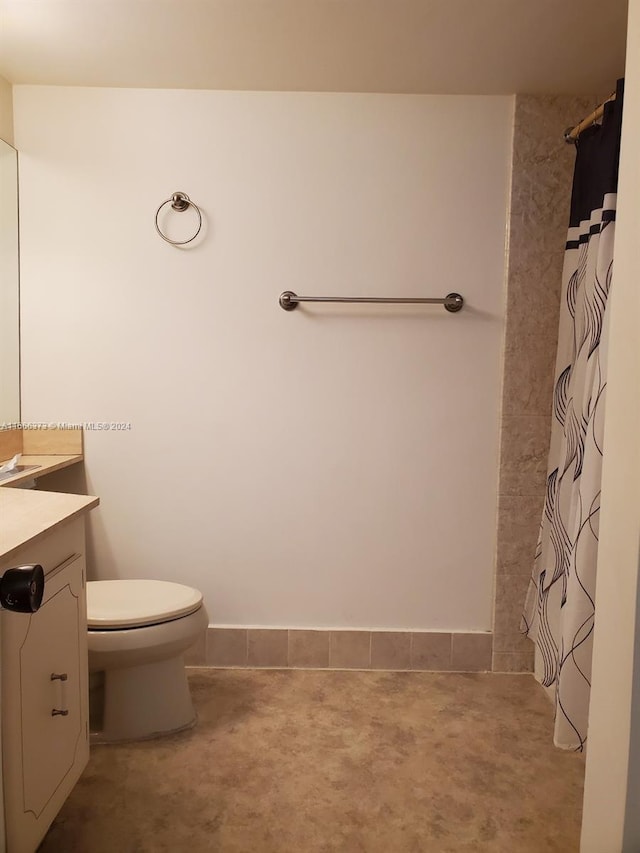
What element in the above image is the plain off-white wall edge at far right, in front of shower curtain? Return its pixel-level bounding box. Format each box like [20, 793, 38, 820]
[580, 0, 640, 853]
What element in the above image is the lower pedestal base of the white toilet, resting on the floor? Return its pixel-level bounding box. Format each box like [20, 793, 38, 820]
[91, 654, 196, 743]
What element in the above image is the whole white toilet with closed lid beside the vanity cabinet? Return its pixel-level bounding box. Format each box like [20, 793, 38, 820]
[87, 580, 209, 743]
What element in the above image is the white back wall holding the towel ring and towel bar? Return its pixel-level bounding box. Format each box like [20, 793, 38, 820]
[14, 86, 513, 630]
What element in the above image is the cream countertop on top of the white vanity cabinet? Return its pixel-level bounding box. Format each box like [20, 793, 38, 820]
[0, 490, 100, 561]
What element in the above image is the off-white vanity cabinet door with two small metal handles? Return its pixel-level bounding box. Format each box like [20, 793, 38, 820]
[2, 555, 89, 853]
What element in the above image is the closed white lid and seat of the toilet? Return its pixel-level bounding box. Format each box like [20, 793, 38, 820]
[87, 580, 202, 629]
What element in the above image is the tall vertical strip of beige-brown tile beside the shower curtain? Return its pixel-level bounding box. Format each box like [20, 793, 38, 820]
[493, 86, 613, 672]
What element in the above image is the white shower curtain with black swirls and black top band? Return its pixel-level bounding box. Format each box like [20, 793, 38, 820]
[522, 81, 623, 751]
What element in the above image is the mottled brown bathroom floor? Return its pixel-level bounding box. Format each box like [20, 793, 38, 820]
[40, 669, 584, 853]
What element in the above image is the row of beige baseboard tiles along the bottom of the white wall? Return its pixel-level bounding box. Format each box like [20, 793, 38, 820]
[185, 627, 492, 672]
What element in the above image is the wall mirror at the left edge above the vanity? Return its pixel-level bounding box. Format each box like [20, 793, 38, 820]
[0, 139, 20, 429]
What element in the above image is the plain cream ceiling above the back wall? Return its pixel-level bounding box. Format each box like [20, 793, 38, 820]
[0, 0, 627, 94]
